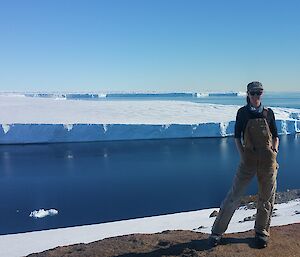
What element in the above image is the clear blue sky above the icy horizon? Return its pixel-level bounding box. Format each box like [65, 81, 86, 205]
[0, 0, 300, 91]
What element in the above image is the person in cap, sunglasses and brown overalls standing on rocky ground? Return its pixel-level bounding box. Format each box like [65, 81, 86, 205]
[209, 81, 279, 248]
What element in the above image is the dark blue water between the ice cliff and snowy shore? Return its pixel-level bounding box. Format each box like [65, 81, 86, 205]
[0, 135, 300, 234]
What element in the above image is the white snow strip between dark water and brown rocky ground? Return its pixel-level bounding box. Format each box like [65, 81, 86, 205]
[0, 199, 300, 257]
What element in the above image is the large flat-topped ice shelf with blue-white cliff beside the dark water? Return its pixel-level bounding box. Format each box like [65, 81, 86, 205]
[0, 96, 300, 144]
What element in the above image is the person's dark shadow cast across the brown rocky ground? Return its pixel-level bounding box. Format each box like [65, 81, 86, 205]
[115, 237, 256, 257]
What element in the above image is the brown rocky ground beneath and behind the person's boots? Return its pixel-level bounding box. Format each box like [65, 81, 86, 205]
[28, 190, 300, 257]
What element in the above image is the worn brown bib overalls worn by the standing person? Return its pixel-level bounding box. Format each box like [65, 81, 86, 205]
[212, 118, 278, 236]
